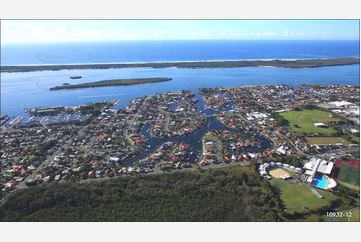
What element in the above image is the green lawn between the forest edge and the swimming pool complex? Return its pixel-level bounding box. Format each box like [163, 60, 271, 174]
[280, 184, 335, 212]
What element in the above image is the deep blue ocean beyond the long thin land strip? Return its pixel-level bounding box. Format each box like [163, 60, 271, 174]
[1, 40, 360, 66]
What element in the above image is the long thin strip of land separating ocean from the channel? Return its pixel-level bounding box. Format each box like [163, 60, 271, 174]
[1, 57, 360, 72]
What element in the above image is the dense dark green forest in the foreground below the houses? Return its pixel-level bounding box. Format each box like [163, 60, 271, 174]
[0, 163, 283, 222]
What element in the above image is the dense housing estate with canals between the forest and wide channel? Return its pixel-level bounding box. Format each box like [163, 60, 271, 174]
[0, 85, 359, 201]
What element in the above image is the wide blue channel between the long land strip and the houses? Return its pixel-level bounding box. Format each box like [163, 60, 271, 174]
[1, 64, 360, 117]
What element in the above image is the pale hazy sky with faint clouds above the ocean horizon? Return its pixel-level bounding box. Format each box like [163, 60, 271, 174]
[1, 20, 360, 43]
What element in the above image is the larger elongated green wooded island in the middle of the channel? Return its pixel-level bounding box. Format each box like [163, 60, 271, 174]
[49, 77, 172, 91]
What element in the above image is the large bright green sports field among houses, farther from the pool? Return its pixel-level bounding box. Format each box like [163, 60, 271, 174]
[280, 109, 340, 133]
